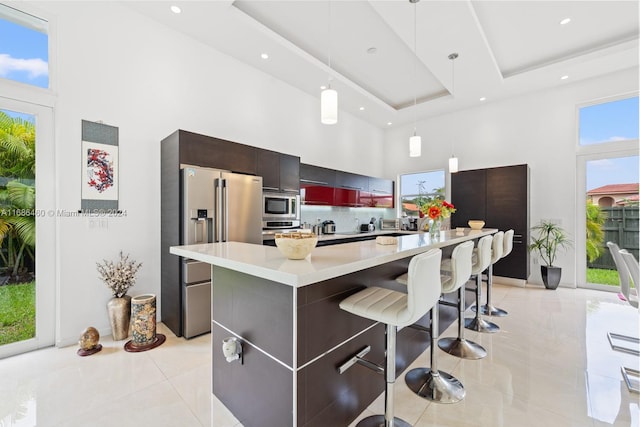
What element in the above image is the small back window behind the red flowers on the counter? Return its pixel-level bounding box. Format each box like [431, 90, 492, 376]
[400, 170, 445, 216]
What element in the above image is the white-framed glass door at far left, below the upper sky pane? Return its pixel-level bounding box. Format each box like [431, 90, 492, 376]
[0, 97, 56, 358]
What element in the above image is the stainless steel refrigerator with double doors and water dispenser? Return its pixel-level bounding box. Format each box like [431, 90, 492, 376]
[179, 166, 262, 338]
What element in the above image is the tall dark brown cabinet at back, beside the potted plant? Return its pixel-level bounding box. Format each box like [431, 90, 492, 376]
[451, 164, 529, 280]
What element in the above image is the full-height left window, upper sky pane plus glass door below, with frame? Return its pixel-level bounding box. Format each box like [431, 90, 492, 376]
[0, 0, 57, 362]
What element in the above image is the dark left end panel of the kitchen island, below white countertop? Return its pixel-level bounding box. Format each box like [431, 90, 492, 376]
[211, 266, 295, 427]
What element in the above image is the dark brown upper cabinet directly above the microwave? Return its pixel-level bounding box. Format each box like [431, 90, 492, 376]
[256, 149, 300, 193]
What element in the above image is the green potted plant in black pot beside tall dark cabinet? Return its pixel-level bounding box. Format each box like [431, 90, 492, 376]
[529, 221, 572, 289]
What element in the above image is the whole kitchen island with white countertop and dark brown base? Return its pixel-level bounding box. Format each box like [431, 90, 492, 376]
[170, 229, 497, 427]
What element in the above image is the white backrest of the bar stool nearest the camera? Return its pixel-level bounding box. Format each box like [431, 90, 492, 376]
[404, 248, 442, 325]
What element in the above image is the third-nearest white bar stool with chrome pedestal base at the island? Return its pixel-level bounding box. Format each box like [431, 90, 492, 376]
[432, 241, 492, 364]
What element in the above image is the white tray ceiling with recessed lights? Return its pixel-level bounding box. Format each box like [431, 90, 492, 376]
[123, 0, 639, 127]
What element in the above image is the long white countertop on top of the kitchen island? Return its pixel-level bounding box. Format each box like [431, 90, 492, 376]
[170, 228, 498, 287]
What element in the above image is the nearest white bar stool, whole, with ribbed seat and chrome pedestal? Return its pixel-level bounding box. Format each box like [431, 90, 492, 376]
[340, 249, 442, 427]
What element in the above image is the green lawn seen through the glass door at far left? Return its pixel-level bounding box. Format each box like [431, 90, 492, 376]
[0, 282, 36, 345]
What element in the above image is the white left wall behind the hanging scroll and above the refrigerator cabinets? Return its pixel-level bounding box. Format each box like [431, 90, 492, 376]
[32, 2, 383, 345]
